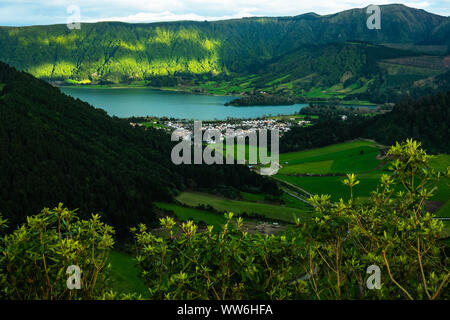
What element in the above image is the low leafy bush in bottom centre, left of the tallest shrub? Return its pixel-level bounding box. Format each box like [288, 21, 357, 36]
[132, 213, 303, 299]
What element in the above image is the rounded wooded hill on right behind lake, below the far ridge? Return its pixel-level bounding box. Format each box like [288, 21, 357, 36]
[232, 41, 450, 103]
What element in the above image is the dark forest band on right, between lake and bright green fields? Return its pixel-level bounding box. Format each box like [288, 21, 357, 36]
[280, 91, 450, 153]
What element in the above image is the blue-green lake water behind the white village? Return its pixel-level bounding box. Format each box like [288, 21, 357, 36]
[61, 88, 306, 120]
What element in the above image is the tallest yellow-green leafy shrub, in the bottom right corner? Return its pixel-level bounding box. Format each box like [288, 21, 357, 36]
[302, 140, 450, 300]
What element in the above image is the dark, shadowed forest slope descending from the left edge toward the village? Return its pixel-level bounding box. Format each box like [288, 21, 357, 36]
[0, 63, 276, 236]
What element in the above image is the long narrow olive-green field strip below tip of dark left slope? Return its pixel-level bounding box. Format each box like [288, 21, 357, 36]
[176, 192, 309, 222]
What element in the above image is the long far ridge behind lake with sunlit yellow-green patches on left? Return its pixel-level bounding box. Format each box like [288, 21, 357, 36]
[0, 5, 447, 82]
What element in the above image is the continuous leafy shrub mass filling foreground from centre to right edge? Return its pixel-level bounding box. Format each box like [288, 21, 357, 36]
[132, 140, 450, 300]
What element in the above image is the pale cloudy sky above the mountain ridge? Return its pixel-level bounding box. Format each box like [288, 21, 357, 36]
[0, 0, 450, 26]
